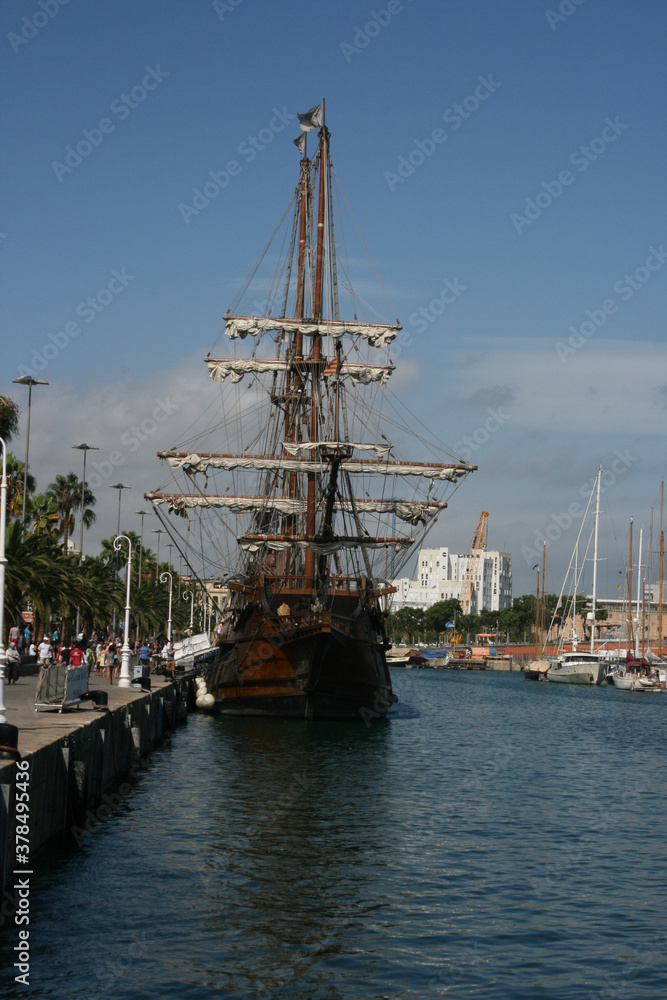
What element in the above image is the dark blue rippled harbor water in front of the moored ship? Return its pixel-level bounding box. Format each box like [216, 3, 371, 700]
[0, 669, 667, 1000]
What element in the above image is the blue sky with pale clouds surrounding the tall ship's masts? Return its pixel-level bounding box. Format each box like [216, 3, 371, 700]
[0, 0, 667, 596]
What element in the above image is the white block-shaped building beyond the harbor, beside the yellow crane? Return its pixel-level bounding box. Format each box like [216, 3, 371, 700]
[392, 547, 512, 614]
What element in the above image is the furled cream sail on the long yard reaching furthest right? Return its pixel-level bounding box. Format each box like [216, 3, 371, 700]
[158, 452, 477, 482]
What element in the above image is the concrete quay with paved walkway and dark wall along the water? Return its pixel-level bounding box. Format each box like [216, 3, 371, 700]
[0, 672, 195, 912]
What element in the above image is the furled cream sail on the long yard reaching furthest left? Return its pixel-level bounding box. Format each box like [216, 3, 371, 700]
[144, 493, 447, 524]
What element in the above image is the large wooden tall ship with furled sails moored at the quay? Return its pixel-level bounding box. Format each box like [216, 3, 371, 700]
[146, 104, 476, 720]
